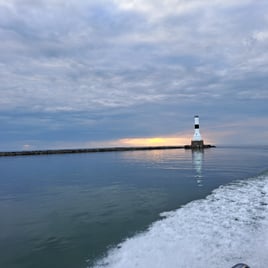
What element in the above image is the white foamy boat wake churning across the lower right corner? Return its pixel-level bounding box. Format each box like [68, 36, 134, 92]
[94, 173, 268, 268]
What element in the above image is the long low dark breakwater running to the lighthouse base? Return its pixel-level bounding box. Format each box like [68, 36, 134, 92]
[0, 144, 216, 157]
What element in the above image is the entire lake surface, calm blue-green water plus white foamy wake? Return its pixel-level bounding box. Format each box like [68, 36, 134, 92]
[0, 147, 268, 268]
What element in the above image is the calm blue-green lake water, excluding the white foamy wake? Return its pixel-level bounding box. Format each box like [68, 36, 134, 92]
[0, 147, 268, 268]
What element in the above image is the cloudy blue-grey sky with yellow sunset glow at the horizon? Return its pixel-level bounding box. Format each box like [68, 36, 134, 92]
[0, 0, 268, 151]
